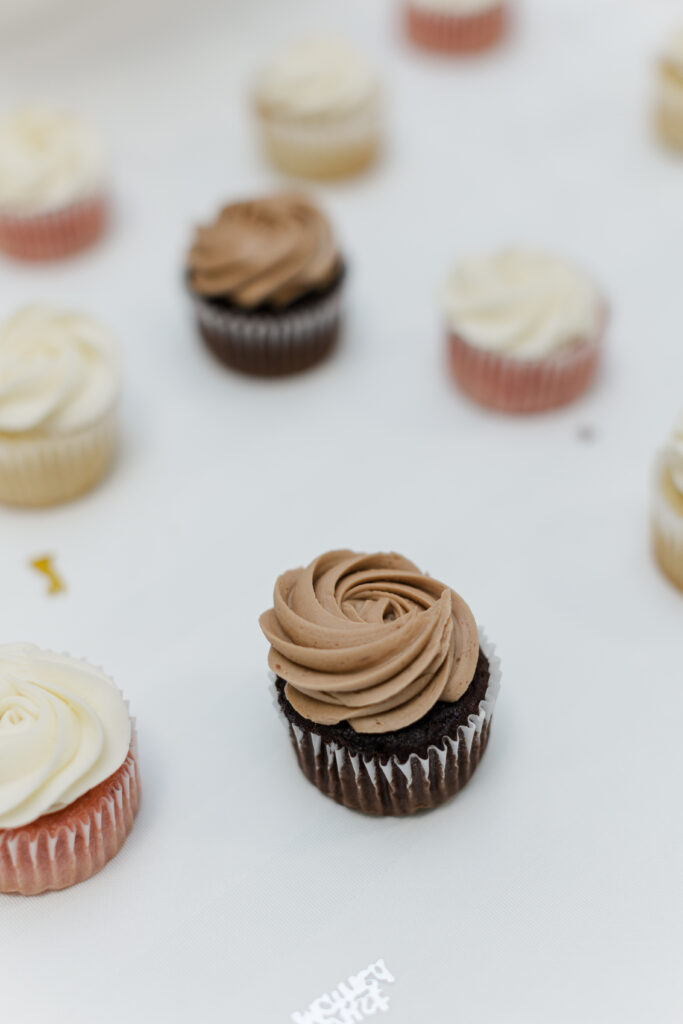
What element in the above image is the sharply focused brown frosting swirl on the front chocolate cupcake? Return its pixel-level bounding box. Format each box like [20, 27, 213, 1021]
[260, 551, 479, 733]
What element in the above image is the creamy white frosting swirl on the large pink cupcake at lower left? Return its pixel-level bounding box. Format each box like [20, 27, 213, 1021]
[0, 644, 131, 828]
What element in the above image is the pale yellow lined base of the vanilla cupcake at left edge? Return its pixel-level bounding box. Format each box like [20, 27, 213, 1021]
[0, 410, 117, 506]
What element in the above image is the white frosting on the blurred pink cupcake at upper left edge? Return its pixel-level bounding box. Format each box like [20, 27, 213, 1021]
[0, 106, 104, 215]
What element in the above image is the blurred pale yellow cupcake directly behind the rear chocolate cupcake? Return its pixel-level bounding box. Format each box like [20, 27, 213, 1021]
[254, 38, 380, 178]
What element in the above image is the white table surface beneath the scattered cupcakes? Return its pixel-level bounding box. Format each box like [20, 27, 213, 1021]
[0, 0, 683, 1024]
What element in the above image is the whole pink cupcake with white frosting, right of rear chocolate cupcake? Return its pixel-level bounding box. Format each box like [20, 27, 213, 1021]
[442, 250, 607, 413]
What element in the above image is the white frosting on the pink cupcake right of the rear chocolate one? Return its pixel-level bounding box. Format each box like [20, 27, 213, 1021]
[442, 249, 605, 360]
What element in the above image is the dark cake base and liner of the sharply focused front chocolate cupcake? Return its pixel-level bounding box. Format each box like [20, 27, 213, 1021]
[275, 650, 496, 815]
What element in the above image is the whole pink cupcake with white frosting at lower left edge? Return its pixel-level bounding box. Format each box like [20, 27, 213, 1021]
[0, 644, 140, 896]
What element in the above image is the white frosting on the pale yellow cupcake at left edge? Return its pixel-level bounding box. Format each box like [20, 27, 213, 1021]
[0, 306, 121, 437]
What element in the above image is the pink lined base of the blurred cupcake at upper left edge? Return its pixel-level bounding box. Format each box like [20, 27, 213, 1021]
[0, 194, 109, 260]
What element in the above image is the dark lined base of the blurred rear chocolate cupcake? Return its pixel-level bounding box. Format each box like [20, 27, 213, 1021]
[194, 280, 342, 376]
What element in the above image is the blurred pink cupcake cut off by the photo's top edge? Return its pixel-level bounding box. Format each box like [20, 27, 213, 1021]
[404, 0, 508, 53]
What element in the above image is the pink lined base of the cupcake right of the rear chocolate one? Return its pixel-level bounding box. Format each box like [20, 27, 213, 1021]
[449, 325, 602, 413]
